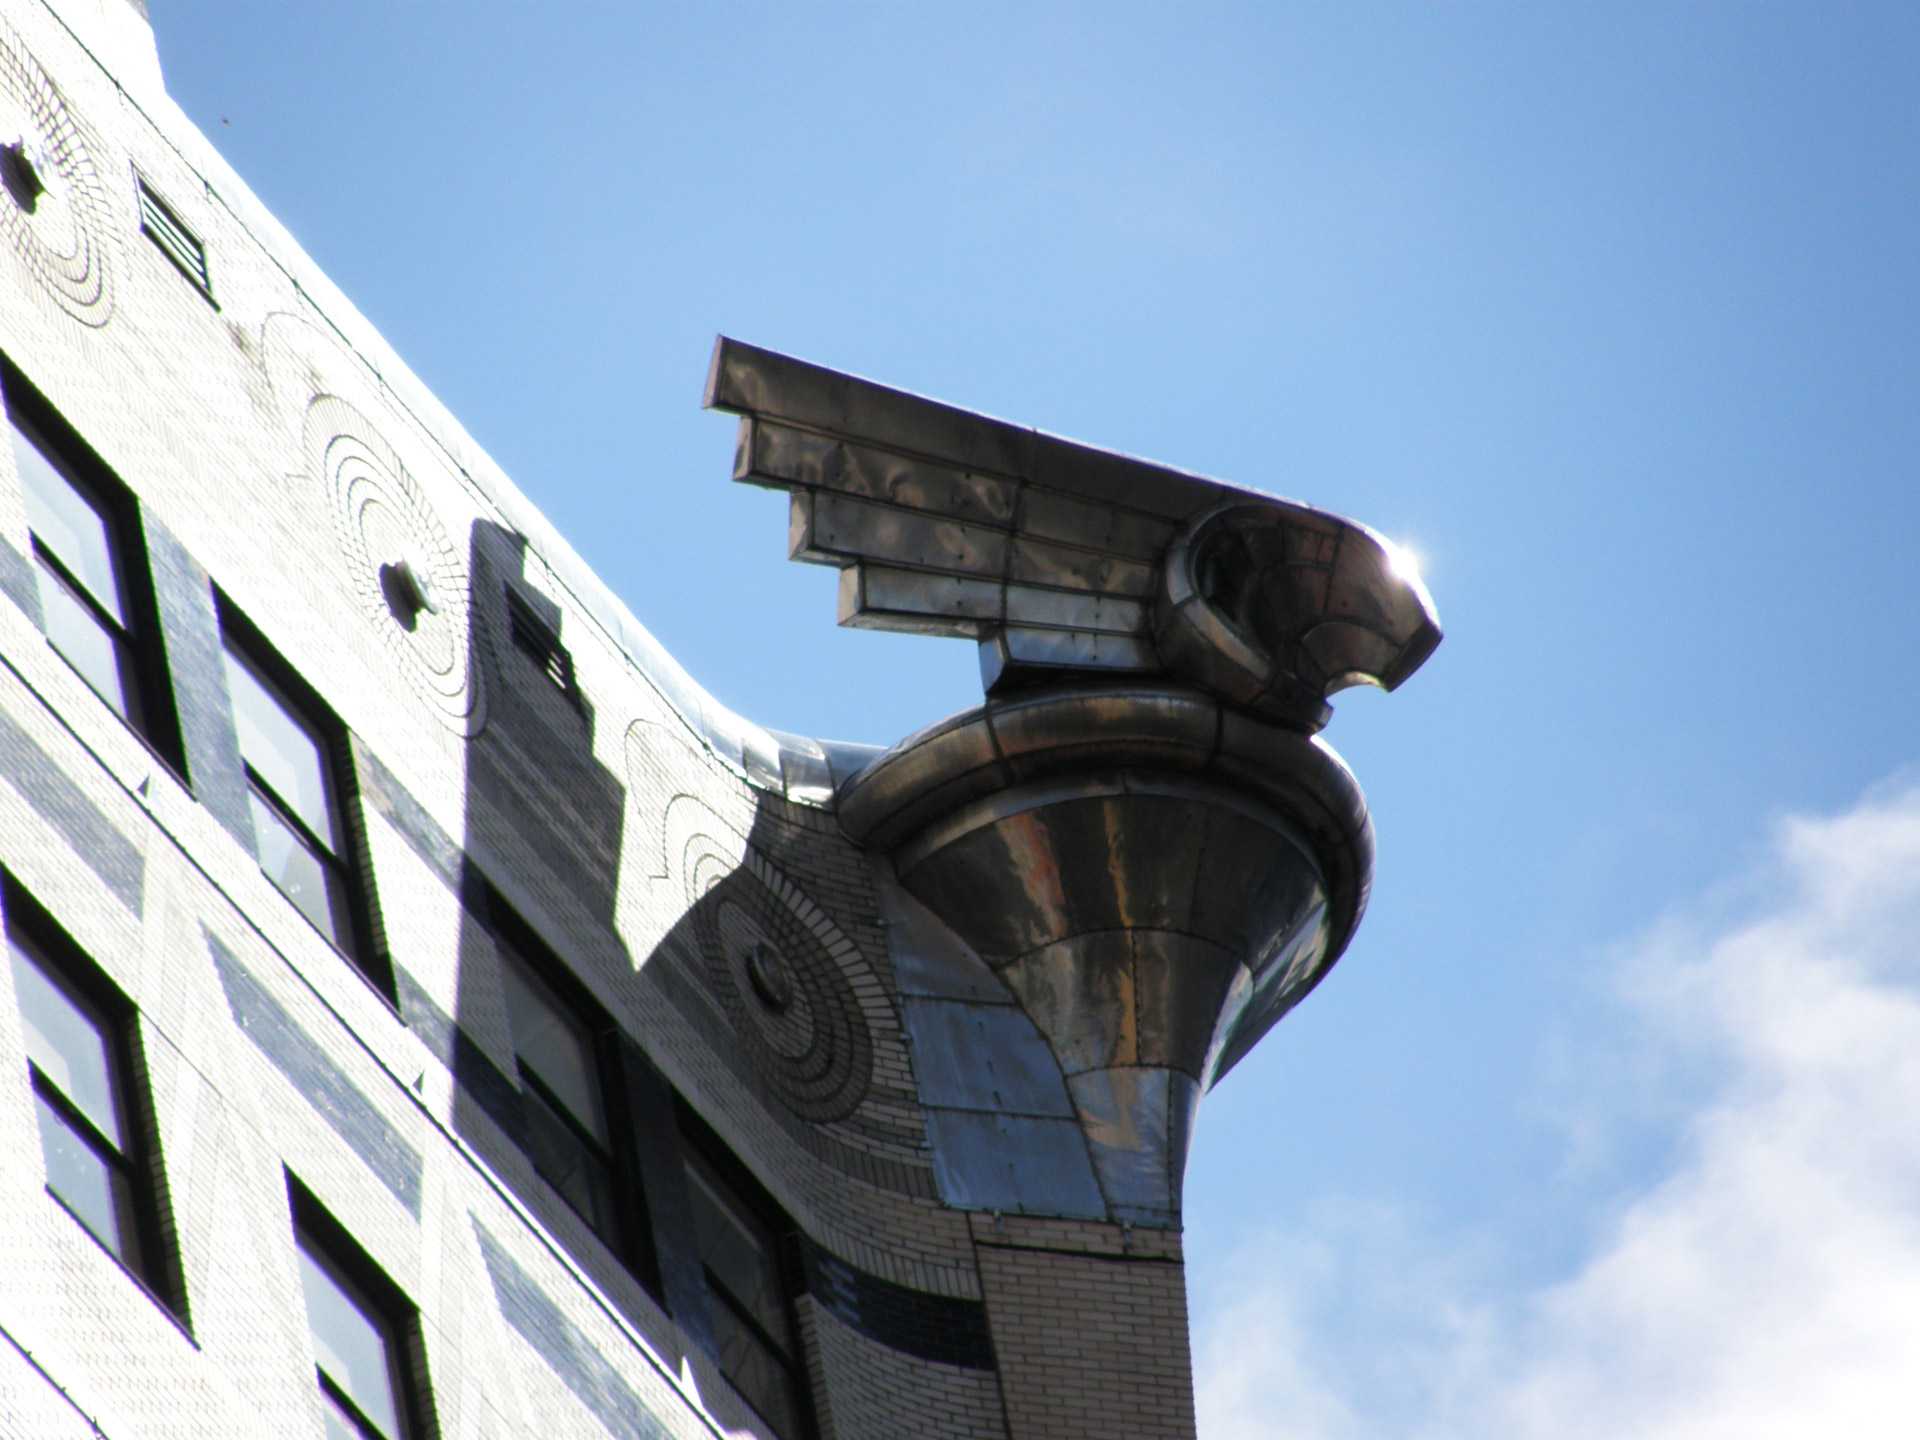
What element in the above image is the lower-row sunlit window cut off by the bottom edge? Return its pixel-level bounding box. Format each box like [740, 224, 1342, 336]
[288, 1177, 428, 1440]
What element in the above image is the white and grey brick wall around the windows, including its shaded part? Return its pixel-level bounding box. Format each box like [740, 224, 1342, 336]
[0, 0, 1228, 1440]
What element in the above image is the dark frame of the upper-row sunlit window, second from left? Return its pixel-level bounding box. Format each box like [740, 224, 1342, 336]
[213, 589, 397, 1012]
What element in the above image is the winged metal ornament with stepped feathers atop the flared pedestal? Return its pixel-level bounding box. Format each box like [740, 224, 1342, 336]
[707, 336, 1440, 730]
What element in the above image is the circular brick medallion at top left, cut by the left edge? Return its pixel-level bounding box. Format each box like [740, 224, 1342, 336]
[0, 27, 113, 328]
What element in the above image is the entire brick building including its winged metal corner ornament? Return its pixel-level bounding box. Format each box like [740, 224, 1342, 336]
[0, 0, 1438, 1440]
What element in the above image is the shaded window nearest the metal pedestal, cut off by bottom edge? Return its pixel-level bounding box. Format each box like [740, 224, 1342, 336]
[682, 1108, 808, 1440]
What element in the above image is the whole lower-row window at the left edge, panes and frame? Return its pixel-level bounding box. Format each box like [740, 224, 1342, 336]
[4, 879, 184, 1315]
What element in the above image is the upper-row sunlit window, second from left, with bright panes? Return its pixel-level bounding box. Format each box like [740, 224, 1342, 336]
[221, 603, 378, 995]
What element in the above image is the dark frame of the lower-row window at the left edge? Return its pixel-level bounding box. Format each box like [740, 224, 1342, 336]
[0, 870, 192, 1338]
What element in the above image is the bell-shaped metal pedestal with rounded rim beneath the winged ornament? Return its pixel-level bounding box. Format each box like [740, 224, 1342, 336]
[841, 687, 1371, 1225]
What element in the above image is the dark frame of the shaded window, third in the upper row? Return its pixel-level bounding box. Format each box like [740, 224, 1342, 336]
[478, 887, 662, 1302]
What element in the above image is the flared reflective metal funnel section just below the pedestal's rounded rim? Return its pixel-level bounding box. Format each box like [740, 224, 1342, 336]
[897, 778, 1331, 1083]
